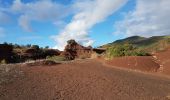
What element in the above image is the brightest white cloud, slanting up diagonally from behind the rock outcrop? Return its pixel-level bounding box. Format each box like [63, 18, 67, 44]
[53, 0, 127, 50]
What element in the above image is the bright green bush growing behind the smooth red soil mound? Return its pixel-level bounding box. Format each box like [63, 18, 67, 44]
[106, 44, 149, 58]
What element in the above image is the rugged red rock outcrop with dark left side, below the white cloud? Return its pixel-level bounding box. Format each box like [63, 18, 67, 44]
[62, 40, 92, 60]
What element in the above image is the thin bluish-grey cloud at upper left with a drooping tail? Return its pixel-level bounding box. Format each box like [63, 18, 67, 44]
[11, 0, 70, 32]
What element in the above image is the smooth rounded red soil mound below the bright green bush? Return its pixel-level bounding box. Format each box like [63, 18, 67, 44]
[106, 56, 160, 72]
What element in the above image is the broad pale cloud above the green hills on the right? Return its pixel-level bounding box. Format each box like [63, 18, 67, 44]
[114, 0, 170, 37]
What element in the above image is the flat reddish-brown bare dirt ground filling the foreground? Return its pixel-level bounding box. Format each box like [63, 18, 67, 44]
[0, 60, 170, 100]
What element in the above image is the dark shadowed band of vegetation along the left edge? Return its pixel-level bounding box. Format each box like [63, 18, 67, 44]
[0, 42, 60, 64]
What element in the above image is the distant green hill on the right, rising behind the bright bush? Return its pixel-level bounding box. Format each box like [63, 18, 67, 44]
[101, 36, 170, 52]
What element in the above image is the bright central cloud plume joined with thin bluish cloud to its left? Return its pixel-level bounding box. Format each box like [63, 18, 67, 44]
[0, 0, 127, 50]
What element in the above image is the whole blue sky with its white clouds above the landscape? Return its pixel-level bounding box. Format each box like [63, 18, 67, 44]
[0, 0, 170, 50]
